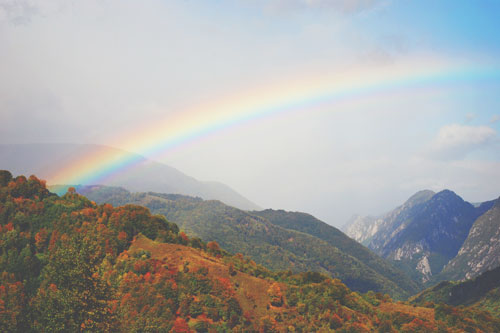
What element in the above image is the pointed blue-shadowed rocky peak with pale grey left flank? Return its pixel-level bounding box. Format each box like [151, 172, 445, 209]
[346, 190, 493, 282]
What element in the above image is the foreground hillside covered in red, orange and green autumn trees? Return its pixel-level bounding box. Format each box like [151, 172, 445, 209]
[0, 171, 500, 332]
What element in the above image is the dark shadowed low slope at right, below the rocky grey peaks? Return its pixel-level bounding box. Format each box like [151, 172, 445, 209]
[410, 267, 500, 317]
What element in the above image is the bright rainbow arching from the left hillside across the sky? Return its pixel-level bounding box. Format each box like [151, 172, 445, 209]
[48, 60, 500, 185]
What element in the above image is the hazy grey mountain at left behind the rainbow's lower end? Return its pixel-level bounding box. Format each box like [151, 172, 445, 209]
[0, 144, 259, 210]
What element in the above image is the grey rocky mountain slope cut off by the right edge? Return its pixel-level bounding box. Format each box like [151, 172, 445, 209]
[441, 198, 500, 280]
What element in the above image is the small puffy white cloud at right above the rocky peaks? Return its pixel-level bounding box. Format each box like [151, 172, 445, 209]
[429, 124, 497, 159]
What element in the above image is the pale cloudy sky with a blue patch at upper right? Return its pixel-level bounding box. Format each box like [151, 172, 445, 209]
[0, 0, 500, 226]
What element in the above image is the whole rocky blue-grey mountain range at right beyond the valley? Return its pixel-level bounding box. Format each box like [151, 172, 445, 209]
[343, 190, 500, 283]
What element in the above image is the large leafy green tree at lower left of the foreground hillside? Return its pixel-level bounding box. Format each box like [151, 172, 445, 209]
[34, 230, 114, 332]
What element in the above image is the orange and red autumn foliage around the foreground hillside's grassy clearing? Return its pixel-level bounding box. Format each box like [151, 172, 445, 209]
[0, 177, 498, 332]
